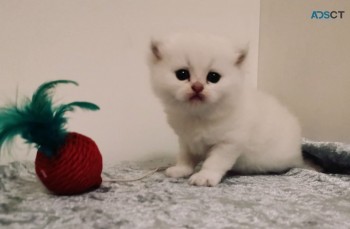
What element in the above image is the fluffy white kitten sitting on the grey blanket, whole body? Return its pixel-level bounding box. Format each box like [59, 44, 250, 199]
[149, 34, 303, 186]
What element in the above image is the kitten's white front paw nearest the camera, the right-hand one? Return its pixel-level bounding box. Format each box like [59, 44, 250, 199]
[189, 170, 222, 187]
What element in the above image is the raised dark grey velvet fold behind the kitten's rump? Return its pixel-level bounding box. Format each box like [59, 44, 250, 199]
[302, 141, 350, 174]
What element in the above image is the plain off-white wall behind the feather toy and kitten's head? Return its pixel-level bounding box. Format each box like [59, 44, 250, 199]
[0, 0, 260, 163]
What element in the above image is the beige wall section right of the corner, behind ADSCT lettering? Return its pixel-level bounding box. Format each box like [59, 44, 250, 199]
[258, 0, 350, 143]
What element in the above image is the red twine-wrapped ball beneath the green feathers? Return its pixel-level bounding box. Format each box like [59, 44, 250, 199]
[35, 133, 102, 195]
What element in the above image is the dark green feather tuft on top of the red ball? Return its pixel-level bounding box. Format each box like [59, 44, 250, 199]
[0, 80, 99, 156]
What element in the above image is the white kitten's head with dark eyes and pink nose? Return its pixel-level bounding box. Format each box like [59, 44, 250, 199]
[149, 34, 246, 113]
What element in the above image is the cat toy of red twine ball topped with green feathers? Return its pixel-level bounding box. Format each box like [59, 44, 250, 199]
[0, 80, 102, 195]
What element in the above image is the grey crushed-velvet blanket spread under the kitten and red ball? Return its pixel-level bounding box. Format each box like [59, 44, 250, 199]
[0, 143, 350, 229]
